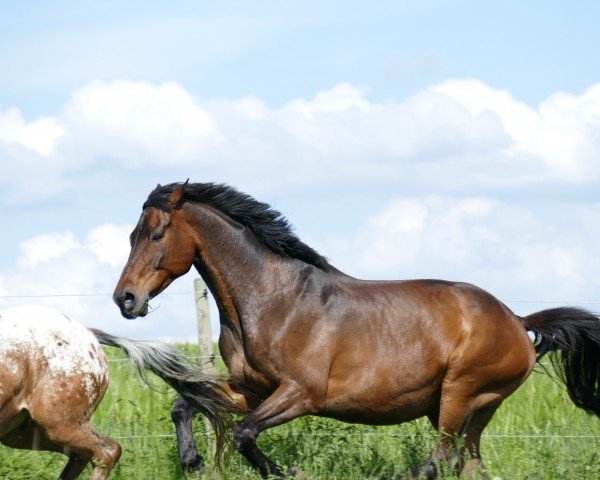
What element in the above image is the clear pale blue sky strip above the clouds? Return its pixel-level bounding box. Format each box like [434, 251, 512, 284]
[0, 0, 600, 116]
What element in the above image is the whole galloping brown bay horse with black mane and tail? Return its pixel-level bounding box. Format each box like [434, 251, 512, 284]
[114, 181, 600, 479]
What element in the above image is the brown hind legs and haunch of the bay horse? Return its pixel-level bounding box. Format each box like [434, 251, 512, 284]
[413, 311, 535, 478]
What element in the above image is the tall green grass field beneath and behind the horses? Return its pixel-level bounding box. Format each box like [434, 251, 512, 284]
[0, 346, 600, 480]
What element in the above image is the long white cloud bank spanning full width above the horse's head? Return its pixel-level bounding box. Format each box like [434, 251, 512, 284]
[0, 79, 600, 203]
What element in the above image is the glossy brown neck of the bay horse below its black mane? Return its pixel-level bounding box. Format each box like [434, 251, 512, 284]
[187, 205, 292, 320]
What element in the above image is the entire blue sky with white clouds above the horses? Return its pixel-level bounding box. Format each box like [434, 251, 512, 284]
[0, 0, 600, 339]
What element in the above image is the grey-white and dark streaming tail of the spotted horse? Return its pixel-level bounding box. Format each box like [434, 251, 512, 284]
[90, 328, 241, 468]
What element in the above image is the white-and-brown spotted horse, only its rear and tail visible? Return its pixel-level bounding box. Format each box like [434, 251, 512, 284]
[0, 305, 229, 480]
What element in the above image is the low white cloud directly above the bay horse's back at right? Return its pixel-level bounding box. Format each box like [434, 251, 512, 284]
[321, 197, 600, 302]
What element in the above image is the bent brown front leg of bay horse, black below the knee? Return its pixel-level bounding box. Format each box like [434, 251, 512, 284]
[233, 382, 310, 478]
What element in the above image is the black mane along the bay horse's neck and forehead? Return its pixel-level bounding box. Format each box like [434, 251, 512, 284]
[143, 183, 329, 271]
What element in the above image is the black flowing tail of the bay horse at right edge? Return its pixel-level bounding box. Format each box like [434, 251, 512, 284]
[523, 307, 600, 416]
